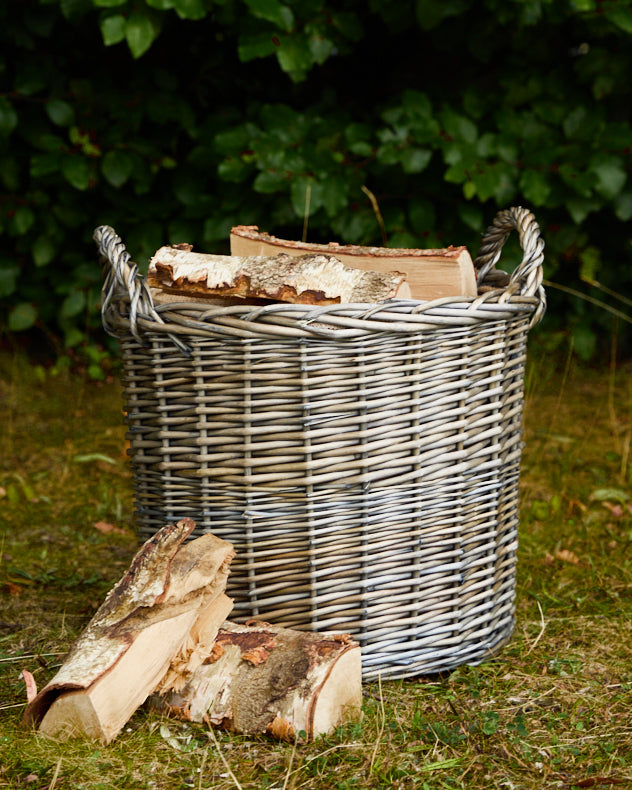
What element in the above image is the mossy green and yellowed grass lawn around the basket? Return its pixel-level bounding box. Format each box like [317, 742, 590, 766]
[0, 355, 632, 790]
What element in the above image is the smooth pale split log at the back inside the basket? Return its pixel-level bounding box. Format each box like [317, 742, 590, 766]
[230, 225, 477, 300]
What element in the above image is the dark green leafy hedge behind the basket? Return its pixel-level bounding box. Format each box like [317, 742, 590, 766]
[0, 0, 632, 368]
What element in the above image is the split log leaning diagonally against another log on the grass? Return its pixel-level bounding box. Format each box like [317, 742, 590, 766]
[24, 519, 234, 743]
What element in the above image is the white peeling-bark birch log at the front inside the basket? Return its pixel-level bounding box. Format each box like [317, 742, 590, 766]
[147, 247, 410, 305]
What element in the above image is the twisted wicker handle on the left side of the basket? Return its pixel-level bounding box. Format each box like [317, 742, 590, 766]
[93, 225, 189, 353]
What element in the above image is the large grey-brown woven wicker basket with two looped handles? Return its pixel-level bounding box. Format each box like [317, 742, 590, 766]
[95, 208, 545, 678]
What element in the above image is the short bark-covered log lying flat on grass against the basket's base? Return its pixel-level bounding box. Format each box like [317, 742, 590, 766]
[154, 622, 362, 740]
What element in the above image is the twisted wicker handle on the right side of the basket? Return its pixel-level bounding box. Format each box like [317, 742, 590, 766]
[474, 206, 546, 326]
